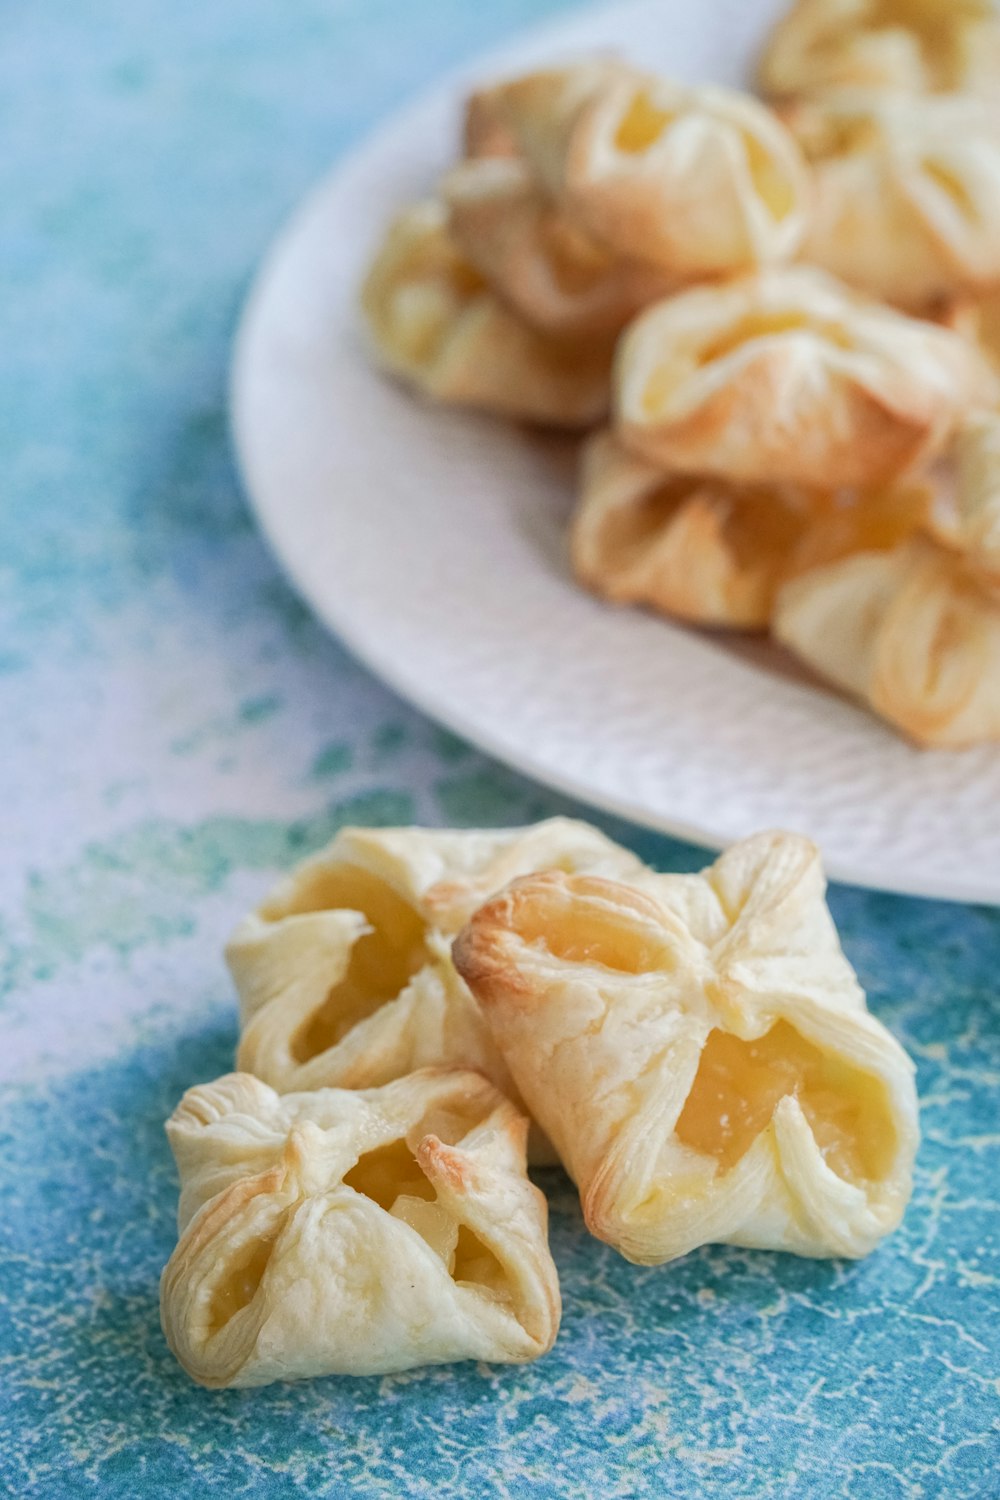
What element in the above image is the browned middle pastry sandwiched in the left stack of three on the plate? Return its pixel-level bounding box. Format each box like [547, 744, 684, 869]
[441, 156, 670, 339]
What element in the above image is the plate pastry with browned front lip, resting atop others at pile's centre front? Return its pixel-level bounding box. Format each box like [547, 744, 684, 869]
[615, 267, 993, 489]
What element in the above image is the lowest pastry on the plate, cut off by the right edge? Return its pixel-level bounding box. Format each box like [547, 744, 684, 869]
[774, 413, 1000, 750]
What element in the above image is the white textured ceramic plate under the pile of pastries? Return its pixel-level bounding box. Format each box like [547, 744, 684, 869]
[234, 0, 1000, 902]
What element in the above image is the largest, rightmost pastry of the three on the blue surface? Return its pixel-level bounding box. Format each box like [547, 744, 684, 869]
[454, 834, 918, 1265]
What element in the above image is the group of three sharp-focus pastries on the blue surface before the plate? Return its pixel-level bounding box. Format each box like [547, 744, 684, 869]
[160, 819, 918, 1386]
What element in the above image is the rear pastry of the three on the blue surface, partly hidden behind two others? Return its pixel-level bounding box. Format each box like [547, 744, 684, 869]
[226, 818, 645, 1161]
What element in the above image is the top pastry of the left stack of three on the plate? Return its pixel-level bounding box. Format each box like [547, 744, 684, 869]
[505, 68, 808, 281]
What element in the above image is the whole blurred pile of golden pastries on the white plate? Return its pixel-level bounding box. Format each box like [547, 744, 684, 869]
[363, 0, 1000, 749]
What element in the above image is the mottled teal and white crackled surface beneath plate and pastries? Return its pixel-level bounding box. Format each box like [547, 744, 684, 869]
[0, 0, 1000, 1500]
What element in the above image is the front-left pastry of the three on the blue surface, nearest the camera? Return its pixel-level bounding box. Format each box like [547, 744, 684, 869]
[160, 1071, 559, 1386]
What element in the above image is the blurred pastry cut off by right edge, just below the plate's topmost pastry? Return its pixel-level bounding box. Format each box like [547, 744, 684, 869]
[790, 95, 1000, 311]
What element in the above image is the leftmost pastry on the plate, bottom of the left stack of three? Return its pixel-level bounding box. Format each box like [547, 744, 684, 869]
[361, 201, 612, 428]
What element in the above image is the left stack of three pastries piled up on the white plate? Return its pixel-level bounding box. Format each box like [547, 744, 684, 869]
[361, 59, 808, 429]
